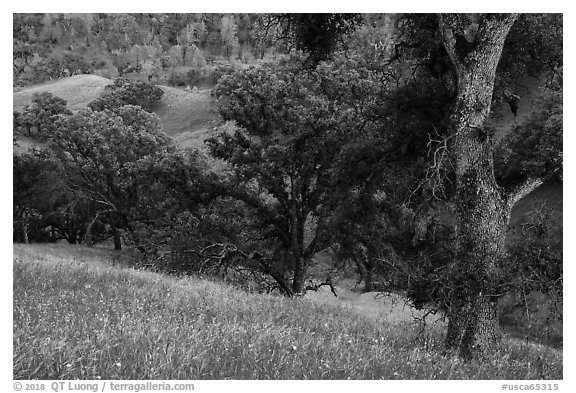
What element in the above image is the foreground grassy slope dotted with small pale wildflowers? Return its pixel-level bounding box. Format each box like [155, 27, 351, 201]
[13, 245, 562, 379]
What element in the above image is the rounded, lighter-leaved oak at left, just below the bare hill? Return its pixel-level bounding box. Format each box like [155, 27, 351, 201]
[50, 105, 169, 249]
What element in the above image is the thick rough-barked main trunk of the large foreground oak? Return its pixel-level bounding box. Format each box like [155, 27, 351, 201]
[440, 14, 516, 358]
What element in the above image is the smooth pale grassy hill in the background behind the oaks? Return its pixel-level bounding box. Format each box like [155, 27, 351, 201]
[13, 75, 217, 147]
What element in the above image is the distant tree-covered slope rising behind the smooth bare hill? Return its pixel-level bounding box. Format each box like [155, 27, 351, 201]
[13, 13, 286, 85]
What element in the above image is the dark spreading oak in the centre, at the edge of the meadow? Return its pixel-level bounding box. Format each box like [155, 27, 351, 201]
[208, 58, 388, 296]
